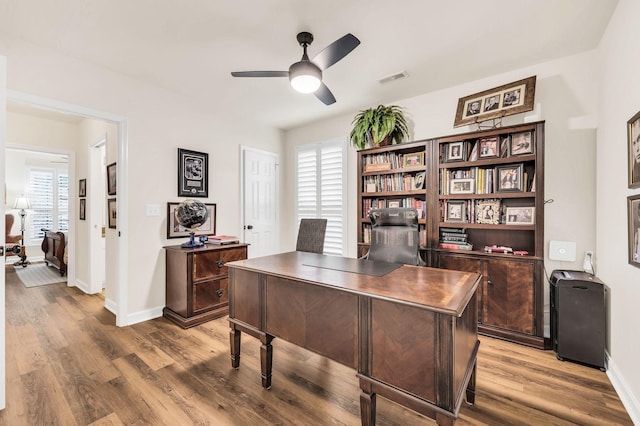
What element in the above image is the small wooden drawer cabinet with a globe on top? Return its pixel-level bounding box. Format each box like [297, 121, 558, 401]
[163, 244, 247, 328]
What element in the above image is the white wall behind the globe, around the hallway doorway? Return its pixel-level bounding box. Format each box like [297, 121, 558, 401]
[0, 34, 281, 324]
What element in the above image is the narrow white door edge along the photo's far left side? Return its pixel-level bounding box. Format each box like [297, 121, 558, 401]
[0, 51, 7, 410]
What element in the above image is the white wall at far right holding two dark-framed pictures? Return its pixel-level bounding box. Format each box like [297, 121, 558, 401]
[596, 0, 640, 424]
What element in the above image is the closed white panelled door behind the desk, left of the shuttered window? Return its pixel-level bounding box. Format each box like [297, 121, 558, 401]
[242, 147, 280, 257]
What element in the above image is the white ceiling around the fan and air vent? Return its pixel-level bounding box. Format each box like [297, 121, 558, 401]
[0, 0, 617, 129]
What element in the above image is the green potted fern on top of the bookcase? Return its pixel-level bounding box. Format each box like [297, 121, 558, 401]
[350, 105, 409, 149]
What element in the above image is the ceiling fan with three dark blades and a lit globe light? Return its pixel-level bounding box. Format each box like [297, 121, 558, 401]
[231, 32, 360, 105]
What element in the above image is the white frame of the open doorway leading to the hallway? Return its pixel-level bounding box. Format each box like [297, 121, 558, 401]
[6, 90, 129, 327]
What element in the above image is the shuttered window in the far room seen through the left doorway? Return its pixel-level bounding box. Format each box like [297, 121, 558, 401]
[26, 168, 69, 245]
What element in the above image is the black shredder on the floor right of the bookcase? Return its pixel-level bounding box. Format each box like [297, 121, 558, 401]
[550, 270, 608, 371]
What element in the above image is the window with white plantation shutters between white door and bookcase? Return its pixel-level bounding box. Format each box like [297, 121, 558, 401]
[296, 139, 347, 256]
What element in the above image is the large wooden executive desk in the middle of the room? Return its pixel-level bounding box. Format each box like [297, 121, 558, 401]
[227, 252, 481, 425]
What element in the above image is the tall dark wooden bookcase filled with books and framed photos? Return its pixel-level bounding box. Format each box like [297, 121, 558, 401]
[358, 122, 548, 348]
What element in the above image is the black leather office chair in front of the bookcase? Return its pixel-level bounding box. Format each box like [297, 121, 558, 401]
[364, 208, 425, 266]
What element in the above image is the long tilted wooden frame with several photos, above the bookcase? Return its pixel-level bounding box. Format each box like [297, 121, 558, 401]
[453, 76, 536, 127]
